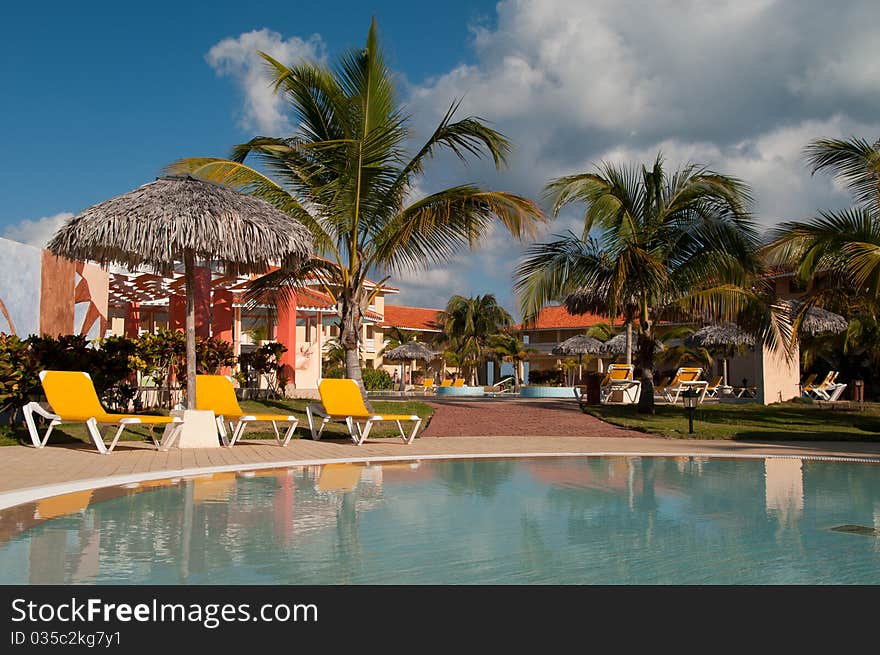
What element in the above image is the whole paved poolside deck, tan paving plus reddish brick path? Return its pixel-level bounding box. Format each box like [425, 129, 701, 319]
[0, 402, 880, 507]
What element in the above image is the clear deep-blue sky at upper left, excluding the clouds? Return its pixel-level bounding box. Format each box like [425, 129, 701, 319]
[0, 0, 494, 223]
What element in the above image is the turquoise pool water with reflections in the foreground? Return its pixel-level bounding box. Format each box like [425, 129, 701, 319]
[0, 457, 880, 584]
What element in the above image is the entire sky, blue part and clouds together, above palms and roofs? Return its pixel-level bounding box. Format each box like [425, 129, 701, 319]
[0, 0, 880, 310]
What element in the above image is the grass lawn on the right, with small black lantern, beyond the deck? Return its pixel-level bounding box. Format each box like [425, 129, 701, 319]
[588, 401, 880, 441]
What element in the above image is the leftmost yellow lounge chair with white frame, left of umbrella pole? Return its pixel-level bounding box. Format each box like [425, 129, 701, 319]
[23, 371, 183, 455]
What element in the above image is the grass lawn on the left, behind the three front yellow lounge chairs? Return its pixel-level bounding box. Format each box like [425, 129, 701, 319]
[0, 400, 433, 446]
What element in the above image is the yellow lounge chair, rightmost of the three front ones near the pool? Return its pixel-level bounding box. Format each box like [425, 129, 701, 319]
[306, 378, 422, 446]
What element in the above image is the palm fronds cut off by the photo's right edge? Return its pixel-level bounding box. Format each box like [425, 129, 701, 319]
[769, 137, 880, 310]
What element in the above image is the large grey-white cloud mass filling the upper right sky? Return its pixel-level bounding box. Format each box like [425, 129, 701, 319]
[208, 0, 880, 316]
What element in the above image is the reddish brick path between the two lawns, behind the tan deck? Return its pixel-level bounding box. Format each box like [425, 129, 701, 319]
[424, 400, 648, 438]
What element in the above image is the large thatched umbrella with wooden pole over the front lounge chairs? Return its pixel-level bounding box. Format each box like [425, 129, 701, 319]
[48, 176, 312, 409]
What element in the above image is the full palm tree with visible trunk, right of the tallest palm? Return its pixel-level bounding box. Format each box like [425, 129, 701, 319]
[515, 155, 788, 412]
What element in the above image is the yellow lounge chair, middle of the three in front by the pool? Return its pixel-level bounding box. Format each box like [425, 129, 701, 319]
[196, 375, 299, 448]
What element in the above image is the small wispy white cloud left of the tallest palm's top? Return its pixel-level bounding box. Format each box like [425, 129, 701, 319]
[206, 28, 325, 136]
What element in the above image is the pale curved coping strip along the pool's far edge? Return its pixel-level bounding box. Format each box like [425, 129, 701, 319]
[0, 451, 880, 511]
